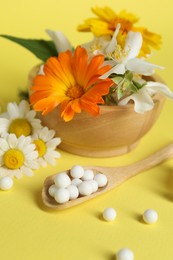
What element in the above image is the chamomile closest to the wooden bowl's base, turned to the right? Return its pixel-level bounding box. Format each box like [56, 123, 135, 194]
[32, 127, 61, 167]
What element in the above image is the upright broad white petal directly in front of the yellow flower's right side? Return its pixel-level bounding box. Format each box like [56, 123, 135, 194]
[124, 31, 142, 60]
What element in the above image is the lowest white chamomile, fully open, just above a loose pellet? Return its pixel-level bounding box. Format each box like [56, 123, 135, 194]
[0, 134, 39, 178]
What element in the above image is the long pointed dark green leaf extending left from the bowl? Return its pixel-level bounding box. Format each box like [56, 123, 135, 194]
[0, 34, 58, 62]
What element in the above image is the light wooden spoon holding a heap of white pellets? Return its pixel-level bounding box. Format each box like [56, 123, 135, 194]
[42, 143, 173, 210]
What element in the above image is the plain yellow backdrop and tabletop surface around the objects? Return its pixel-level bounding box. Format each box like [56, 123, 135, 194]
[0, 0, 173, 260]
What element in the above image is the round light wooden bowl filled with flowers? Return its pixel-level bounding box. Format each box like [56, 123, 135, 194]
[34, 79, 165, 157]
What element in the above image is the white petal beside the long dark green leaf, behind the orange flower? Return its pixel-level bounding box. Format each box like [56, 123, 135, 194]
[46, 29, 72, 53]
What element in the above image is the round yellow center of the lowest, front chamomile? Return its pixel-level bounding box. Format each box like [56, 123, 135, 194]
[3, 149, 25, 170]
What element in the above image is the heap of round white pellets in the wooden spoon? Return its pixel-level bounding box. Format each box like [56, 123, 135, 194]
[48, 165, 108, 204]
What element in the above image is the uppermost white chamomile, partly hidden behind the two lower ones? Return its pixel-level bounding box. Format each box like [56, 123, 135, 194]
[0, 100, 41, 137]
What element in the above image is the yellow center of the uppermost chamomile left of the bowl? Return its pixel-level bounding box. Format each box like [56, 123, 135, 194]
[9, 118, 32, 137]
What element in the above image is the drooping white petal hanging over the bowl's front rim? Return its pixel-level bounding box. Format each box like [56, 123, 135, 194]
[119, 87, 154, 114]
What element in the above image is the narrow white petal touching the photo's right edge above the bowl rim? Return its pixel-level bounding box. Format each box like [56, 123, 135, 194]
[146, 81, 173, 98]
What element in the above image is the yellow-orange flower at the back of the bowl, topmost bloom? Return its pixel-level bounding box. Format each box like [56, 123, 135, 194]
[78, 7, 161, 56]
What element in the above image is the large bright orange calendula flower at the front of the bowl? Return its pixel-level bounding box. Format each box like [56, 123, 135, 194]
[30, 46, 113, 121]
